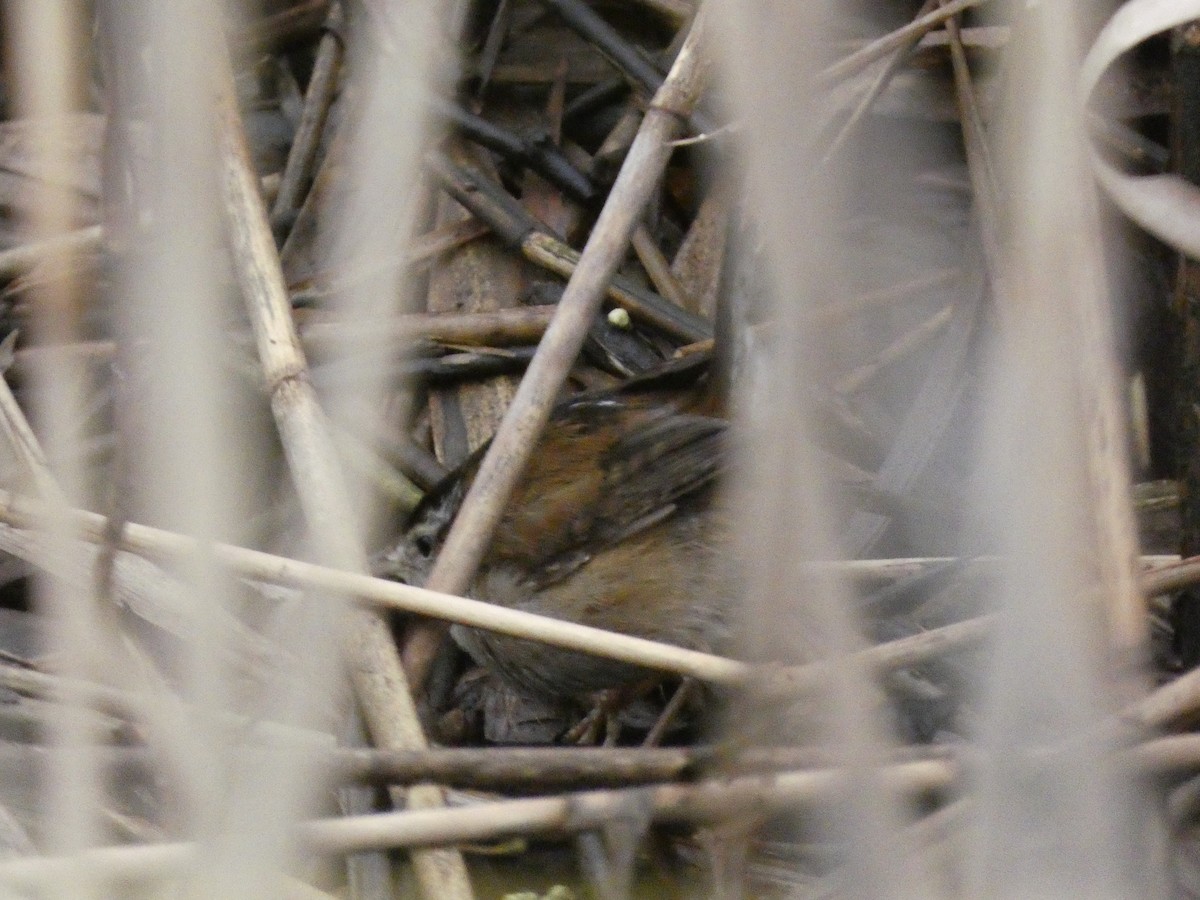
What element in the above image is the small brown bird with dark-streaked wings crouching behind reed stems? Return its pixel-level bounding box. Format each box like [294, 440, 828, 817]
[376, 394, 736, 697]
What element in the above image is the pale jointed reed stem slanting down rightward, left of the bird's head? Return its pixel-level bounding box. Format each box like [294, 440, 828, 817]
[208, 31, 473, 900]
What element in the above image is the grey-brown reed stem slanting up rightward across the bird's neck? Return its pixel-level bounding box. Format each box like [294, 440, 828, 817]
[404, 14, 708, 688]
